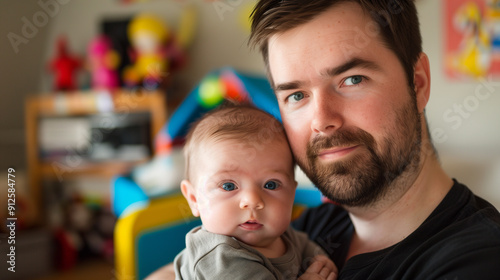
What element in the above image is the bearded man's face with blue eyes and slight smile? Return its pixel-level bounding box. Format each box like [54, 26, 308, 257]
[269, 3, 421, 206]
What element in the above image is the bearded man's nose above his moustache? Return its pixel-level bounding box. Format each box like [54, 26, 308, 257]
[311, 90, 344, 134]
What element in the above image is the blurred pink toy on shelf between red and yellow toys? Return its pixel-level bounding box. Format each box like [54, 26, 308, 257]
[88, 35, 120, 90]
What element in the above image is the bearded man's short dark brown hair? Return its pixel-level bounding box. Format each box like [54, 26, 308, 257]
[250, 0, 422, 88]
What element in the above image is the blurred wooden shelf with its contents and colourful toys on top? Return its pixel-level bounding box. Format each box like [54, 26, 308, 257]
[25, 8, 196, 228]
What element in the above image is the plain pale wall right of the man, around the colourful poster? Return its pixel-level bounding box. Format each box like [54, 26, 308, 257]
[417, 0, 500, 209]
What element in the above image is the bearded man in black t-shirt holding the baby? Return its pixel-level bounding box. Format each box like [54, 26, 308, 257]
[149, 0, 500, 280]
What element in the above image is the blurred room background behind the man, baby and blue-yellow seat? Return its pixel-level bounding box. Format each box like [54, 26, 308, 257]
[0, 0, 500, 279]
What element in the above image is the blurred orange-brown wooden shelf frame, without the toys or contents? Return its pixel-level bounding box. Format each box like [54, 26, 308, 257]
[25, 91, 166, 224]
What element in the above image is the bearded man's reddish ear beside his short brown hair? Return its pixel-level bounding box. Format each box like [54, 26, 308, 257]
[413, 52, 431, 113]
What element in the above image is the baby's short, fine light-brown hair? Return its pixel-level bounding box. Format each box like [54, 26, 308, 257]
[184, 103, 295, 180]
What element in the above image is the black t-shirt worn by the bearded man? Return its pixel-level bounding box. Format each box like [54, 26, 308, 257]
[293, 181, 500, 280]
